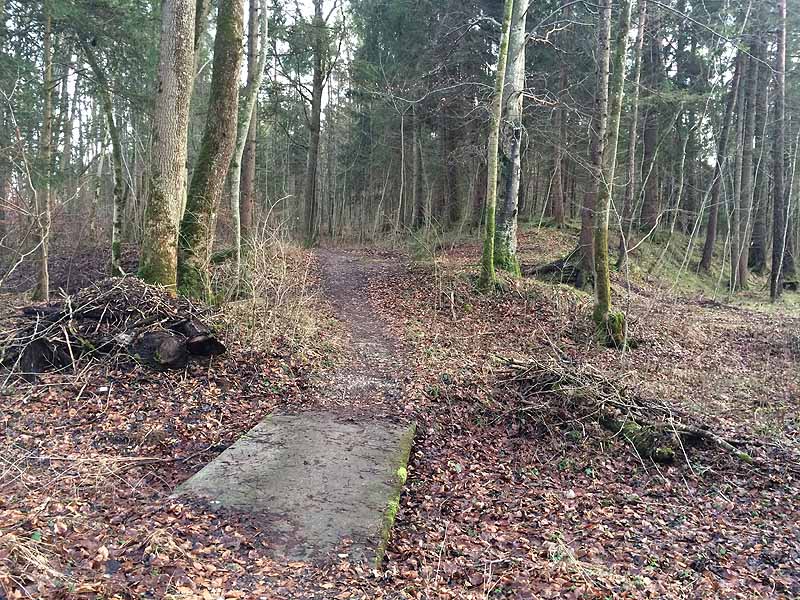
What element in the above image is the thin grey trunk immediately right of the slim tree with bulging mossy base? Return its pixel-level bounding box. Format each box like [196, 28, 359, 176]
[617, 0, 647, 268]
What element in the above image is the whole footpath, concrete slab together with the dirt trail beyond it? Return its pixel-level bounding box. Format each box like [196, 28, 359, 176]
[177, 250, 415, 564]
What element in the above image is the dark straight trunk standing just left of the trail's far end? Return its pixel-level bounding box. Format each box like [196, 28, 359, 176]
[303, 0, 325, 247]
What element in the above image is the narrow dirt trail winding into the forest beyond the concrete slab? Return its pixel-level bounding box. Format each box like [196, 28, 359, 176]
[317, 249, 407, 414]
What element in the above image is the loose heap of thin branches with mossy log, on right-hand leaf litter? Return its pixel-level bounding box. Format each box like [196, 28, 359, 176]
[499, 357, 754, 464]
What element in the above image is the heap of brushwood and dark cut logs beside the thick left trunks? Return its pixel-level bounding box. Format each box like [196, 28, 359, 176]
[0, 277, 226, 378]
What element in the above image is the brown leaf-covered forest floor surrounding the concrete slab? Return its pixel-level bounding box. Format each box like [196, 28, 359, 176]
[0, 230, 800, 599]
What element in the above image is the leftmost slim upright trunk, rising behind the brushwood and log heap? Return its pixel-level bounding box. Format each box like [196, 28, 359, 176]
[32, 0, 53, 301]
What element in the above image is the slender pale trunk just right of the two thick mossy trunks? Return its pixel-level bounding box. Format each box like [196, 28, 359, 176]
[228, 0, 268, 277]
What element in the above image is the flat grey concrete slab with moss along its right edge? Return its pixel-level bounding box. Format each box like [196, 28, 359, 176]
[176, 413, 415, 561]
